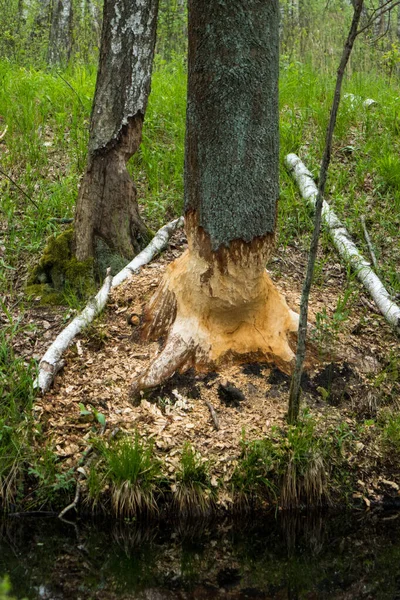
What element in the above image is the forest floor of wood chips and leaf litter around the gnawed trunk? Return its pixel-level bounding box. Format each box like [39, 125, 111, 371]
[8, 231, 400, 508]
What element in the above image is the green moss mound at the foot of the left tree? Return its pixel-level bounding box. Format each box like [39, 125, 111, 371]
[27, 229, 95, 304]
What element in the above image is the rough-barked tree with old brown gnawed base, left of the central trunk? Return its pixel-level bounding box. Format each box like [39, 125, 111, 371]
[74, 0, 158, 270]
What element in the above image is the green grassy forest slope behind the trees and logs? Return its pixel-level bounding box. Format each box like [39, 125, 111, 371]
[0, 0, 400, 516]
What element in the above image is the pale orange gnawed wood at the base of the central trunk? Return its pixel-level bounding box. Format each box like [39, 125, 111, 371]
[132, 215, 298, 395]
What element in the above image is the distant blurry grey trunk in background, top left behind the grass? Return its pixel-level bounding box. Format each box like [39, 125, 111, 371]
[48, 0, 72, 67]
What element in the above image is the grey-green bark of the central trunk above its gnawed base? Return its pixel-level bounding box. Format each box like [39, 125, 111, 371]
[185, 0, 279, 250]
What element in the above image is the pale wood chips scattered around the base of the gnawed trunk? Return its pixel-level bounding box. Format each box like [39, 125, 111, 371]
[34, 232, 399, 492]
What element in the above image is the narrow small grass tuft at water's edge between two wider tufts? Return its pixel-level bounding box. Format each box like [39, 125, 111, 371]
[172, 442, 213, 515]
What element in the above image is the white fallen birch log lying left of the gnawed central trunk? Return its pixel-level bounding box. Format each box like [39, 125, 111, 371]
[34, 217, 183, 394]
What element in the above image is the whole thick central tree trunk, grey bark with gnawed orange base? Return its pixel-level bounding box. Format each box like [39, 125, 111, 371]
[132, 0, 297, 393]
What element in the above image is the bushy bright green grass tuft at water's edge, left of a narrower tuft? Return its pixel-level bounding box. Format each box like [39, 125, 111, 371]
[100, 431, 161, 517]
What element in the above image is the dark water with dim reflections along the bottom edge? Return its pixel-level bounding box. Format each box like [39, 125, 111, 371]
[0, 513, 400, 600]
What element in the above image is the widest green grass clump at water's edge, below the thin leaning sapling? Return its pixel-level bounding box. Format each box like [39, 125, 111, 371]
[232, 413, 350, 508]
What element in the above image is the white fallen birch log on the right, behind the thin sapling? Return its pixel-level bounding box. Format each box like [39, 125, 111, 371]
[285, 154, 400, 335]
